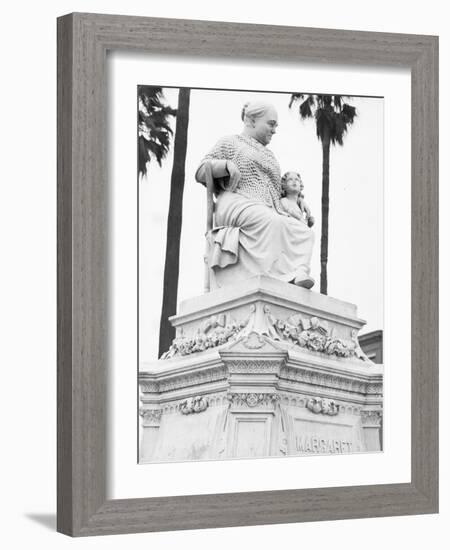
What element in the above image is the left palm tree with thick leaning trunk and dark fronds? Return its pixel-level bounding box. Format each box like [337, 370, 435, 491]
[138, 86, 190, 356]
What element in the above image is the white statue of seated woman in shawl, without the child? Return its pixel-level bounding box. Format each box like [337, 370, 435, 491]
[195, 101, 314, 289]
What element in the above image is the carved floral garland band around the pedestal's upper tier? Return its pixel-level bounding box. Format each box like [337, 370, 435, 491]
[161, 304, 370, 362]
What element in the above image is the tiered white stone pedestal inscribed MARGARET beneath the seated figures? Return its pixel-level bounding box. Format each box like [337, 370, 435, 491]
[139, 277, 383, 462]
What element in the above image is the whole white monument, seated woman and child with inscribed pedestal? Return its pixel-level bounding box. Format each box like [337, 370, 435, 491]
[139, 103, 383, 463]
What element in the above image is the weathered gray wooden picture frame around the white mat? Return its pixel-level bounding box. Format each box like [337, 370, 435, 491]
[57, 13, 438, 536]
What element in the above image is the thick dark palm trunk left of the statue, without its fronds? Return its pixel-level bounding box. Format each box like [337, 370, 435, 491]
[159, 88, 190, 357]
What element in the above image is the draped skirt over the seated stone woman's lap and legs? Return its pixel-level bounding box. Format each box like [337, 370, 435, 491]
[208, 191, 314, 289]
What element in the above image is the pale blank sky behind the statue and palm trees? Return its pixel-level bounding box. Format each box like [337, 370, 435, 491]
[139, 87, 384, 361]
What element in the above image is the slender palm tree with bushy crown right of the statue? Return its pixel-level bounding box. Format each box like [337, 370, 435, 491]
[289, 93, 356, 294]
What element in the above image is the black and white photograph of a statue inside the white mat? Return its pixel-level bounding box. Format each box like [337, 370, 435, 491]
[137, 84, 384, 464]
